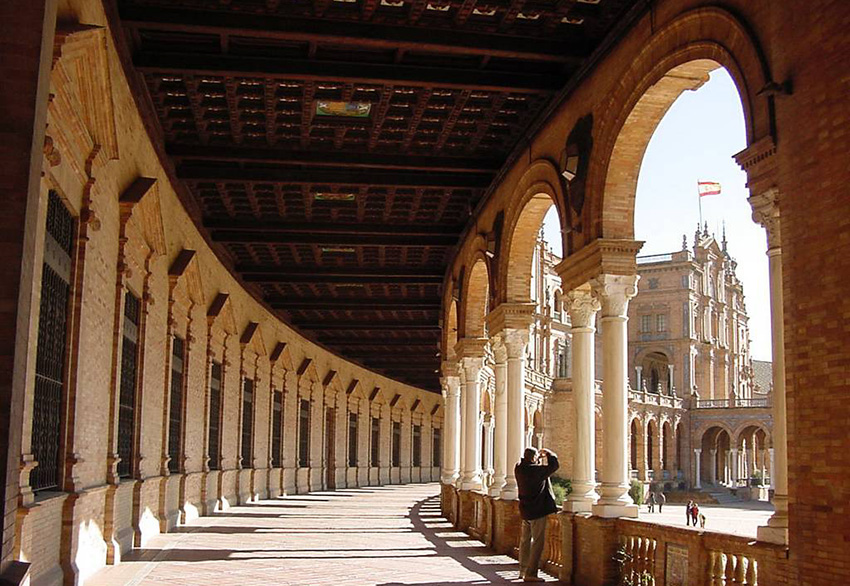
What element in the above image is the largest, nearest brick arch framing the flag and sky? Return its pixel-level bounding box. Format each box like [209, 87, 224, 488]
[583, 7, 771, 241]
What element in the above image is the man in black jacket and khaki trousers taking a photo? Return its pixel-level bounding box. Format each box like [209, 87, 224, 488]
[514, 448, 558, 582]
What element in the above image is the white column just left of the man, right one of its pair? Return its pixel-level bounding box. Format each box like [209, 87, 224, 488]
[501, 329, 528, 500]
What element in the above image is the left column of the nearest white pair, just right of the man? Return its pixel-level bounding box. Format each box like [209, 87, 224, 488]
[564, 288, 604, 513]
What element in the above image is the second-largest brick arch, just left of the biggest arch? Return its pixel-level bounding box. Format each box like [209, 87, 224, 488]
[496, 159, 566, 303]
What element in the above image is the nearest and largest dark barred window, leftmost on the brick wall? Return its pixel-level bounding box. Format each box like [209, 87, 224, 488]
[30, 191, 75, 491]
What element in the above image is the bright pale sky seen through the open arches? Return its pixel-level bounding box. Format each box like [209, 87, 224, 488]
[544, 68, 771, 360]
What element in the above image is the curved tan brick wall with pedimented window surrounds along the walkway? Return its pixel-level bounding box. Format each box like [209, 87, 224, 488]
[3, 0, 442, 586]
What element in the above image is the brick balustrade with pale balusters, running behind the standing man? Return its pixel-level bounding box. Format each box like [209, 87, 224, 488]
[442, 486, 789, 586]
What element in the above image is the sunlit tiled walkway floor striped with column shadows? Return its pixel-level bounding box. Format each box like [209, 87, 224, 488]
[86, 484, 554, 586]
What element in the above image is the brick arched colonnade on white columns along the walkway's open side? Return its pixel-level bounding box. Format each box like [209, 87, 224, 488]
[442, 7, 787, 541]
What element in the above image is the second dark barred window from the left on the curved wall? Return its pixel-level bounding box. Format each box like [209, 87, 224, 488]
[118, 291, 141, 478]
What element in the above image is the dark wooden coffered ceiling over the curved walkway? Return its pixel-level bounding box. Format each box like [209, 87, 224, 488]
[114, 0, 634, 391]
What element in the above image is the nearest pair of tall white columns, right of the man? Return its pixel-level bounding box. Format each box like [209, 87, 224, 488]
[565, 275, 639, 517]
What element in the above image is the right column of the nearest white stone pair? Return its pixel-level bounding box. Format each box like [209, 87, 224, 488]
[592, 275, 639, 517]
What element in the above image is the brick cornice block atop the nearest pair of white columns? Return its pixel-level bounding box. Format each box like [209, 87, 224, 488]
[555, 238, 643, 291]
